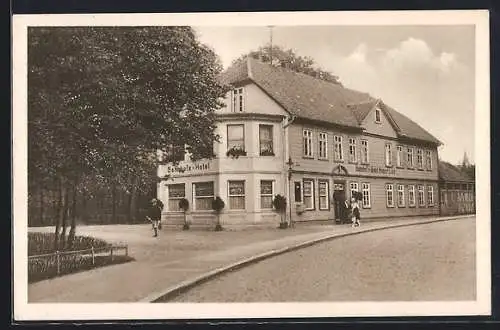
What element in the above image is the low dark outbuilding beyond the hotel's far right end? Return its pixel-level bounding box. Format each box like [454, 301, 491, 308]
[439, 161, 476, 216]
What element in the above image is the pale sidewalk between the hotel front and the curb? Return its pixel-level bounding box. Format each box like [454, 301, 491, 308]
[28, 215, 473, 303]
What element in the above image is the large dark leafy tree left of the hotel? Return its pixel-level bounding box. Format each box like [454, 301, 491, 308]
[28, 27, 227, 248]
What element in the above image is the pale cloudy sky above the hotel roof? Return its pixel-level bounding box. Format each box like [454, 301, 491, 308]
[195, 26, 475, 163]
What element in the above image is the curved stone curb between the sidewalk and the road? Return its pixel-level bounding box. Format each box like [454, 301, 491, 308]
[144, 215, 473, 303]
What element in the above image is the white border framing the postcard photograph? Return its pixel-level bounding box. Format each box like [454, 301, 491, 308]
[12, 10, 491, 321]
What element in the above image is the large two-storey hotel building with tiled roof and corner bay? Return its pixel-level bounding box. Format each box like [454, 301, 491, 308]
[158, 58, 440, 227]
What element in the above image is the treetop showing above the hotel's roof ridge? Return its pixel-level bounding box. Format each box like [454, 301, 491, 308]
[233, 44, 342, 85]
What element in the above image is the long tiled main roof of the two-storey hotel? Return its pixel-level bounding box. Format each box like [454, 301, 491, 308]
[222, 57, 440, 144]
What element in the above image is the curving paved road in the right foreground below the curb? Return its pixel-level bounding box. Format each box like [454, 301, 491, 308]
[173, 218, 476, 302]
